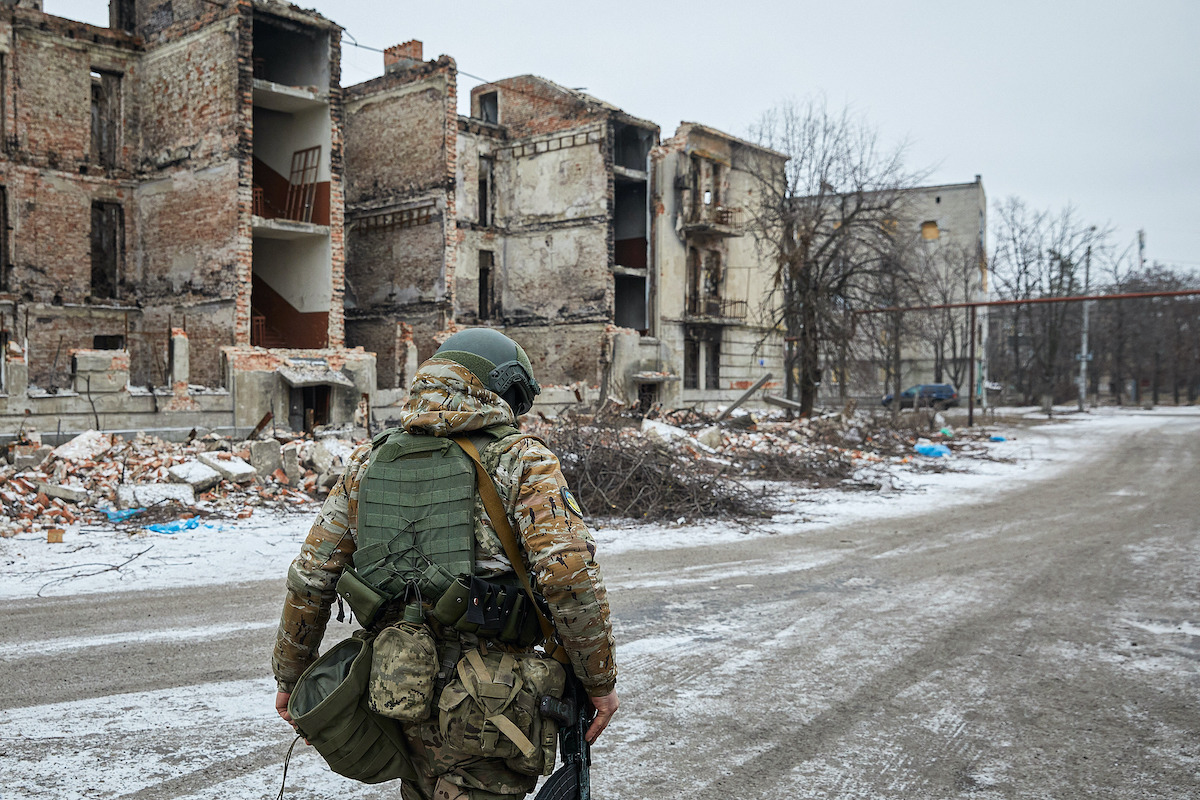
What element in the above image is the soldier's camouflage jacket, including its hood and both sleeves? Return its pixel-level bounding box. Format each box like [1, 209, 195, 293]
[271, 359, 617, 696]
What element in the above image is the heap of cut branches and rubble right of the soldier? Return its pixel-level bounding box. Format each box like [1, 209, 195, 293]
[527, 409, 1008, 519]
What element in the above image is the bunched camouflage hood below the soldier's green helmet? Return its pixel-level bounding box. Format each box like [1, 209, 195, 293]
[400, 359, 517, 437]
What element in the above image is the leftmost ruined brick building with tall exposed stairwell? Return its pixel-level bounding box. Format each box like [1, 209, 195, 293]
[0, 0, 376, 434]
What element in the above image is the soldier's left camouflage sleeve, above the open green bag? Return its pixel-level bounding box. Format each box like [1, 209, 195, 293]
[271, 444, 371, 692]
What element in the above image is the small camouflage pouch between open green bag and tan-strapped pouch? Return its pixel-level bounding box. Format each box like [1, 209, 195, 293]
[367, 620, 438, 722]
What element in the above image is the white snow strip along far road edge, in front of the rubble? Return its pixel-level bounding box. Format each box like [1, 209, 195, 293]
[7, 408, 1200, 600]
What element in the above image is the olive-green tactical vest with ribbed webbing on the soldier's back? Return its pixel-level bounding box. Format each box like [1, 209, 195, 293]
[338, 426, 520, 626]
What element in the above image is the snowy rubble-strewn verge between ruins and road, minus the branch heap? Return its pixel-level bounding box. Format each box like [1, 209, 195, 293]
[0, 409, 1200, 599]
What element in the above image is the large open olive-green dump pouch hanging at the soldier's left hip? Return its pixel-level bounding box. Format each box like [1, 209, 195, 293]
[288, 633, 416, 783]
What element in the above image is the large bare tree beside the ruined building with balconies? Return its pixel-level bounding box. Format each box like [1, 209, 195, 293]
[749, 100, 924, 414]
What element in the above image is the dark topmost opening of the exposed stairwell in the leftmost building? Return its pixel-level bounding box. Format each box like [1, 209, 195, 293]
[253, 13, 329, 94]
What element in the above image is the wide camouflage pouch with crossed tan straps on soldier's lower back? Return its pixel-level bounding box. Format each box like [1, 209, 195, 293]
[438, 650, 566, 775]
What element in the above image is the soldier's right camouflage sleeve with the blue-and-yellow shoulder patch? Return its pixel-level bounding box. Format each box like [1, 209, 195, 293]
[497, 439, 617, 697]
